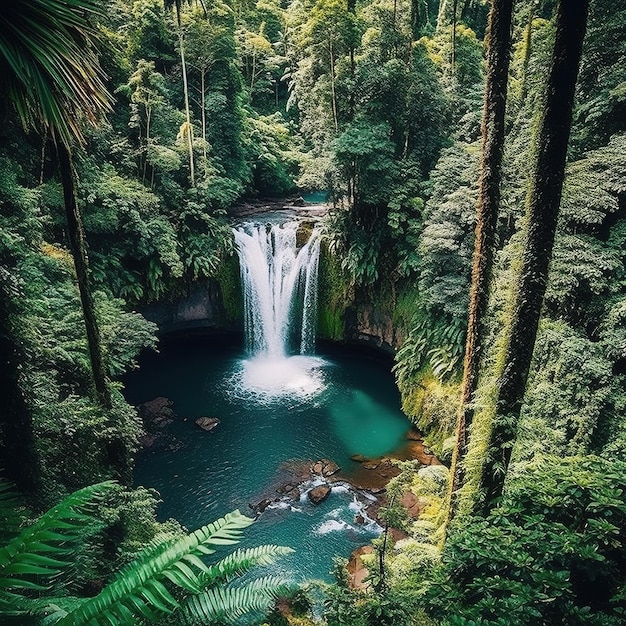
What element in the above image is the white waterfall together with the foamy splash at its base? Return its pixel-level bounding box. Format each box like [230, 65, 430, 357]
[234, 222, 325, 401]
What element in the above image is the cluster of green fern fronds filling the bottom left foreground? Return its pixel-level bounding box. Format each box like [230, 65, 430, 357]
[0, 480, 292, 626]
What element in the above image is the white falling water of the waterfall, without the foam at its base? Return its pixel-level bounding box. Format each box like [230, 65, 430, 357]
[234, 222, 320, 359]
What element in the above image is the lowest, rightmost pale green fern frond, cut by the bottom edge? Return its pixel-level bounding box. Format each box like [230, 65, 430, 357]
[182, 576, 290, 624]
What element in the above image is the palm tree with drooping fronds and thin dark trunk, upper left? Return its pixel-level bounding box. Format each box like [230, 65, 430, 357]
[0, 0, 111, 408]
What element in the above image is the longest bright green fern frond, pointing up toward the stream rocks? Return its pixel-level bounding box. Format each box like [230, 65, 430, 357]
[57, 511, 254, 626]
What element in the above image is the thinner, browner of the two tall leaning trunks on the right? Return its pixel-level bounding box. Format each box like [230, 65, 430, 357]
[448, 0, 514, 521]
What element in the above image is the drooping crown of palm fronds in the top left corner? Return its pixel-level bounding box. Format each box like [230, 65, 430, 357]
[0, 0, 111, 146]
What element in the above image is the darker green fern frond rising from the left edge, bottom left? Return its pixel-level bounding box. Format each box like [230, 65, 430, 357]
[0, 481, 115, 601]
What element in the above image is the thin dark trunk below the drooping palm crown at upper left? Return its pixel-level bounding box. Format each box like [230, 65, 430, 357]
[57, 143, 111, 409]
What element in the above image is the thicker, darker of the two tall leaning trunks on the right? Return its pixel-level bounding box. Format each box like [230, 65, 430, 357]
[481, 0, 589, 512]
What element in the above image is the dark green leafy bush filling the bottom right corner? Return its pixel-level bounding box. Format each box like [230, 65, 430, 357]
[427, 456, 626, 626]
